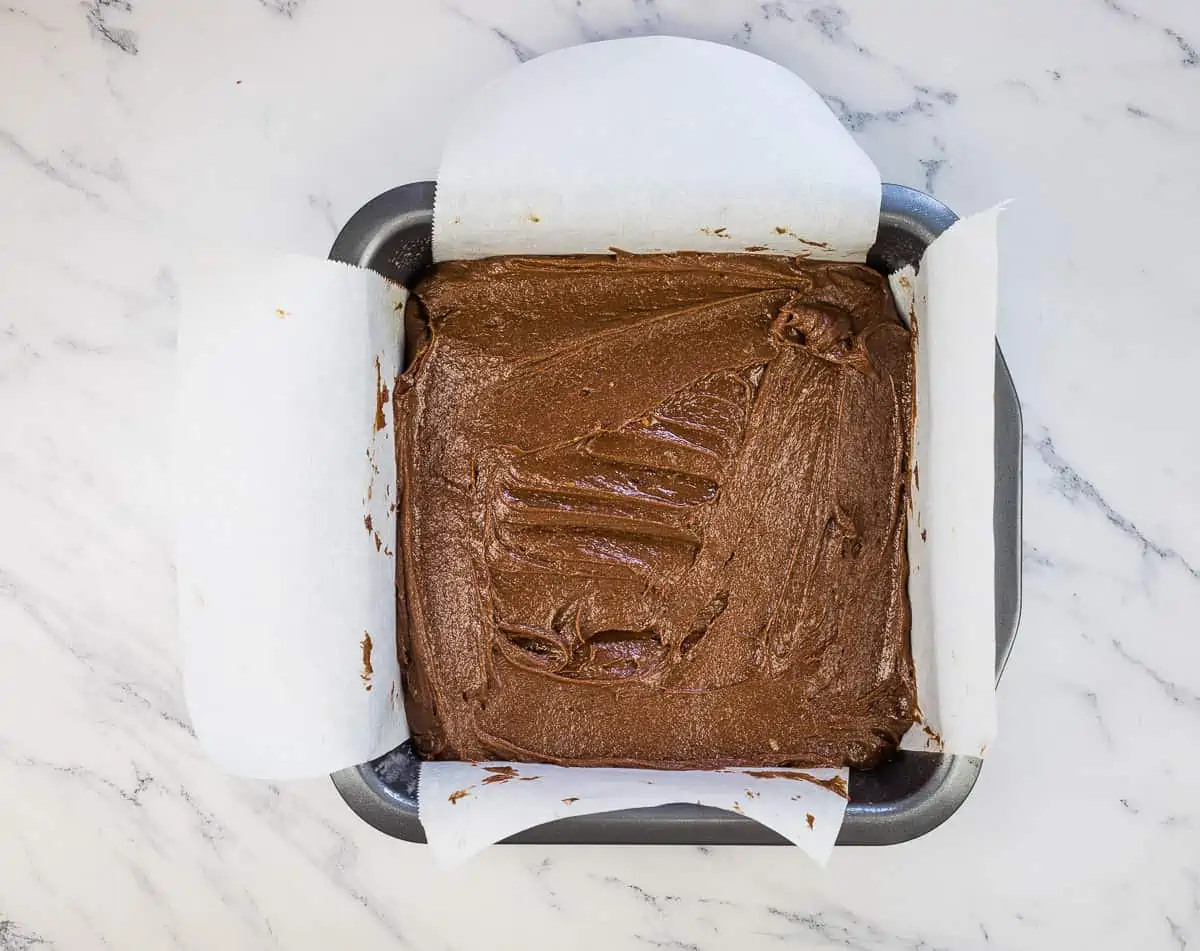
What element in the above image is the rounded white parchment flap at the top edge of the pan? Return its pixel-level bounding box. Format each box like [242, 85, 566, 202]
[433, 36, 881, 261]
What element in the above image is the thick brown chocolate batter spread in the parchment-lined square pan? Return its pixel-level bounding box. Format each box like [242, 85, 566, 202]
[396, 253, 914, 767]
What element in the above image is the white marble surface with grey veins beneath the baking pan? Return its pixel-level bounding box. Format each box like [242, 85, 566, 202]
[0, 0, 1200, 951]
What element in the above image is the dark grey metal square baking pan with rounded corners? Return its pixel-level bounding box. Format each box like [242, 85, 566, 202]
[329, 181, 1021, 845]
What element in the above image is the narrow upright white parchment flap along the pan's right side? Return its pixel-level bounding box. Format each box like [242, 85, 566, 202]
[890, 207, 1001, 756]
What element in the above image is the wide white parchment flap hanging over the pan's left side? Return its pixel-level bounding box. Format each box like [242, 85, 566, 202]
[173, 255, 408, 778]
